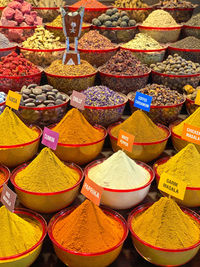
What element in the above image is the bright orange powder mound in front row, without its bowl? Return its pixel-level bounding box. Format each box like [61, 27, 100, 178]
[53, 200, 123, 253]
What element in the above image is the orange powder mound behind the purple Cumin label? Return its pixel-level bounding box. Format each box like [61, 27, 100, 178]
[52, 108, 104, 144]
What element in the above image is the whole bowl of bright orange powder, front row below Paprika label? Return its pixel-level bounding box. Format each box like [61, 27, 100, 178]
[48, 200, 128, 267]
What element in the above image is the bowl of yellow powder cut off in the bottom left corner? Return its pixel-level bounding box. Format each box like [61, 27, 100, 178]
[0, 206, 47, 267]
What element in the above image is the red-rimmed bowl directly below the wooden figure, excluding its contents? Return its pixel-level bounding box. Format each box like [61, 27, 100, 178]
[45, 71, 97, 94]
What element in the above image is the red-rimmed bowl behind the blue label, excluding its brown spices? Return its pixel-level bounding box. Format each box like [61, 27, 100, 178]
[127, 92, 185, 125]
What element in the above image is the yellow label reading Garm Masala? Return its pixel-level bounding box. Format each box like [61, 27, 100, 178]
[158, 173, 187, 200]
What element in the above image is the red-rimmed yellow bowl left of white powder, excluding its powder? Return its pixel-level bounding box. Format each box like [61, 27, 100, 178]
[10, 163, 84, 213]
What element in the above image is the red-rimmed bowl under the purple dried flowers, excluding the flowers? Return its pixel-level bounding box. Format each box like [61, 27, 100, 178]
[81, 93, 128, 127]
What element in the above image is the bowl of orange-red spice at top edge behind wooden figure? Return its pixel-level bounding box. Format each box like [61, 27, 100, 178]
[68, 0, 110, 23]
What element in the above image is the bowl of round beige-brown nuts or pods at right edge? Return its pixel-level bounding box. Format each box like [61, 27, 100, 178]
[150, 54, 200, 93]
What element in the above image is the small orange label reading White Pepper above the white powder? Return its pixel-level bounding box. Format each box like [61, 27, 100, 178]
[117, 130, 135, 152]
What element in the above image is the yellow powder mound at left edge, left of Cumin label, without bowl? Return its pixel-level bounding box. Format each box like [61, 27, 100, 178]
[0, 107, 39, 146]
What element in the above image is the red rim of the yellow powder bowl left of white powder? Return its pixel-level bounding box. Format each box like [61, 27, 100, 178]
[10, 162, 84, 196]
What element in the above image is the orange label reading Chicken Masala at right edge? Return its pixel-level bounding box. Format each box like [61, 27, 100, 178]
[182, 123, 200, 145]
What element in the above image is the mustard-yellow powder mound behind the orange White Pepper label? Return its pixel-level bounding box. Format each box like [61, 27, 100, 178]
[111, 110, 167, 143]
